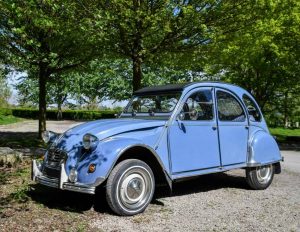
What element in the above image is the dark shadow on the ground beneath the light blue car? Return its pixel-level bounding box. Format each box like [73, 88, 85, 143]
[27, 173, 249, 214]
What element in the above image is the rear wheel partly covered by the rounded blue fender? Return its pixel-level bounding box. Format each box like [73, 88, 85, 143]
[246, 164, 275, 190]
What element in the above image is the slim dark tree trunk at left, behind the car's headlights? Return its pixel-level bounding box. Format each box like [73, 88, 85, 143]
[39, 64, 49, 139]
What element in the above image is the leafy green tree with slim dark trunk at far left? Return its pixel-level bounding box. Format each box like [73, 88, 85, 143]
[0, 0, 99, 136]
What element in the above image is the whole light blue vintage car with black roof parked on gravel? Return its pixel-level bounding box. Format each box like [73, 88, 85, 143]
[32, 82, 282, 215]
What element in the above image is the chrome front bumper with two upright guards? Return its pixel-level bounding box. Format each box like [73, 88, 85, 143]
[31, 160, 96, 194]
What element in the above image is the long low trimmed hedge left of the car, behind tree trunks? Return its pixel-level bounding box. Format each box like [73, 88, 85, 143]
[0, 108, 118, 120]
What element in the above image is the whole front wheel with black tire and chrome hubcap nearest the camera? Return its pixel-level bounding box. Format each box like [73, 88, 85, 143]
[106, 159, 155, 216]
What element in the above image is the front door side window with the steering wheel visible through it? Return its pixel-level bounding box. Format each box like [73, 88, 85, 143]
[181, 89, 214, 121]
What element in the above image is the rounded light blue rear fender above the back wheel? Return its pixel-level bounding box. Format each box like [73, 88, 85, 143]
[247, 130, 282, 167]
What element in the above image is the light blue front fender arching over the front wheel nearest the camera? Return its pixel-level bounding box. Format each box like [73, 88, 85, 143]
[72, 138, 164, 186]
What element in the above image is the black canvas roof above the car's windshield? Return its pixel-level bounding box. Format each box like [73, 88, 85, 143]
[134, 83, 193, 95]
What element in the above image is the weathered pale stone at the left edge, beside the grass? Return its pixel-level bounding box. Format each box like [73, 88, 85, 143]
[0, 147, 23, 167]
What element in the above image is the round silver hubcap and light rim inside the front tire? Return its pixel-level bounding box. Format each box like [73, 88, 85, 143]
[118, 167, 153, 210]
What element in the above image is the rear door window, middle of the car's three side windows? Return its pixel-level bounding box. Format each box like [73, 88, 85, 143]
[217, 91, 246, 122]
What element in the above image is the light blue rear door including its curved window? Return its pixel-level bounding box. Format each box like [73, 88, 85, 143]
[216, 89, 249, 166]
